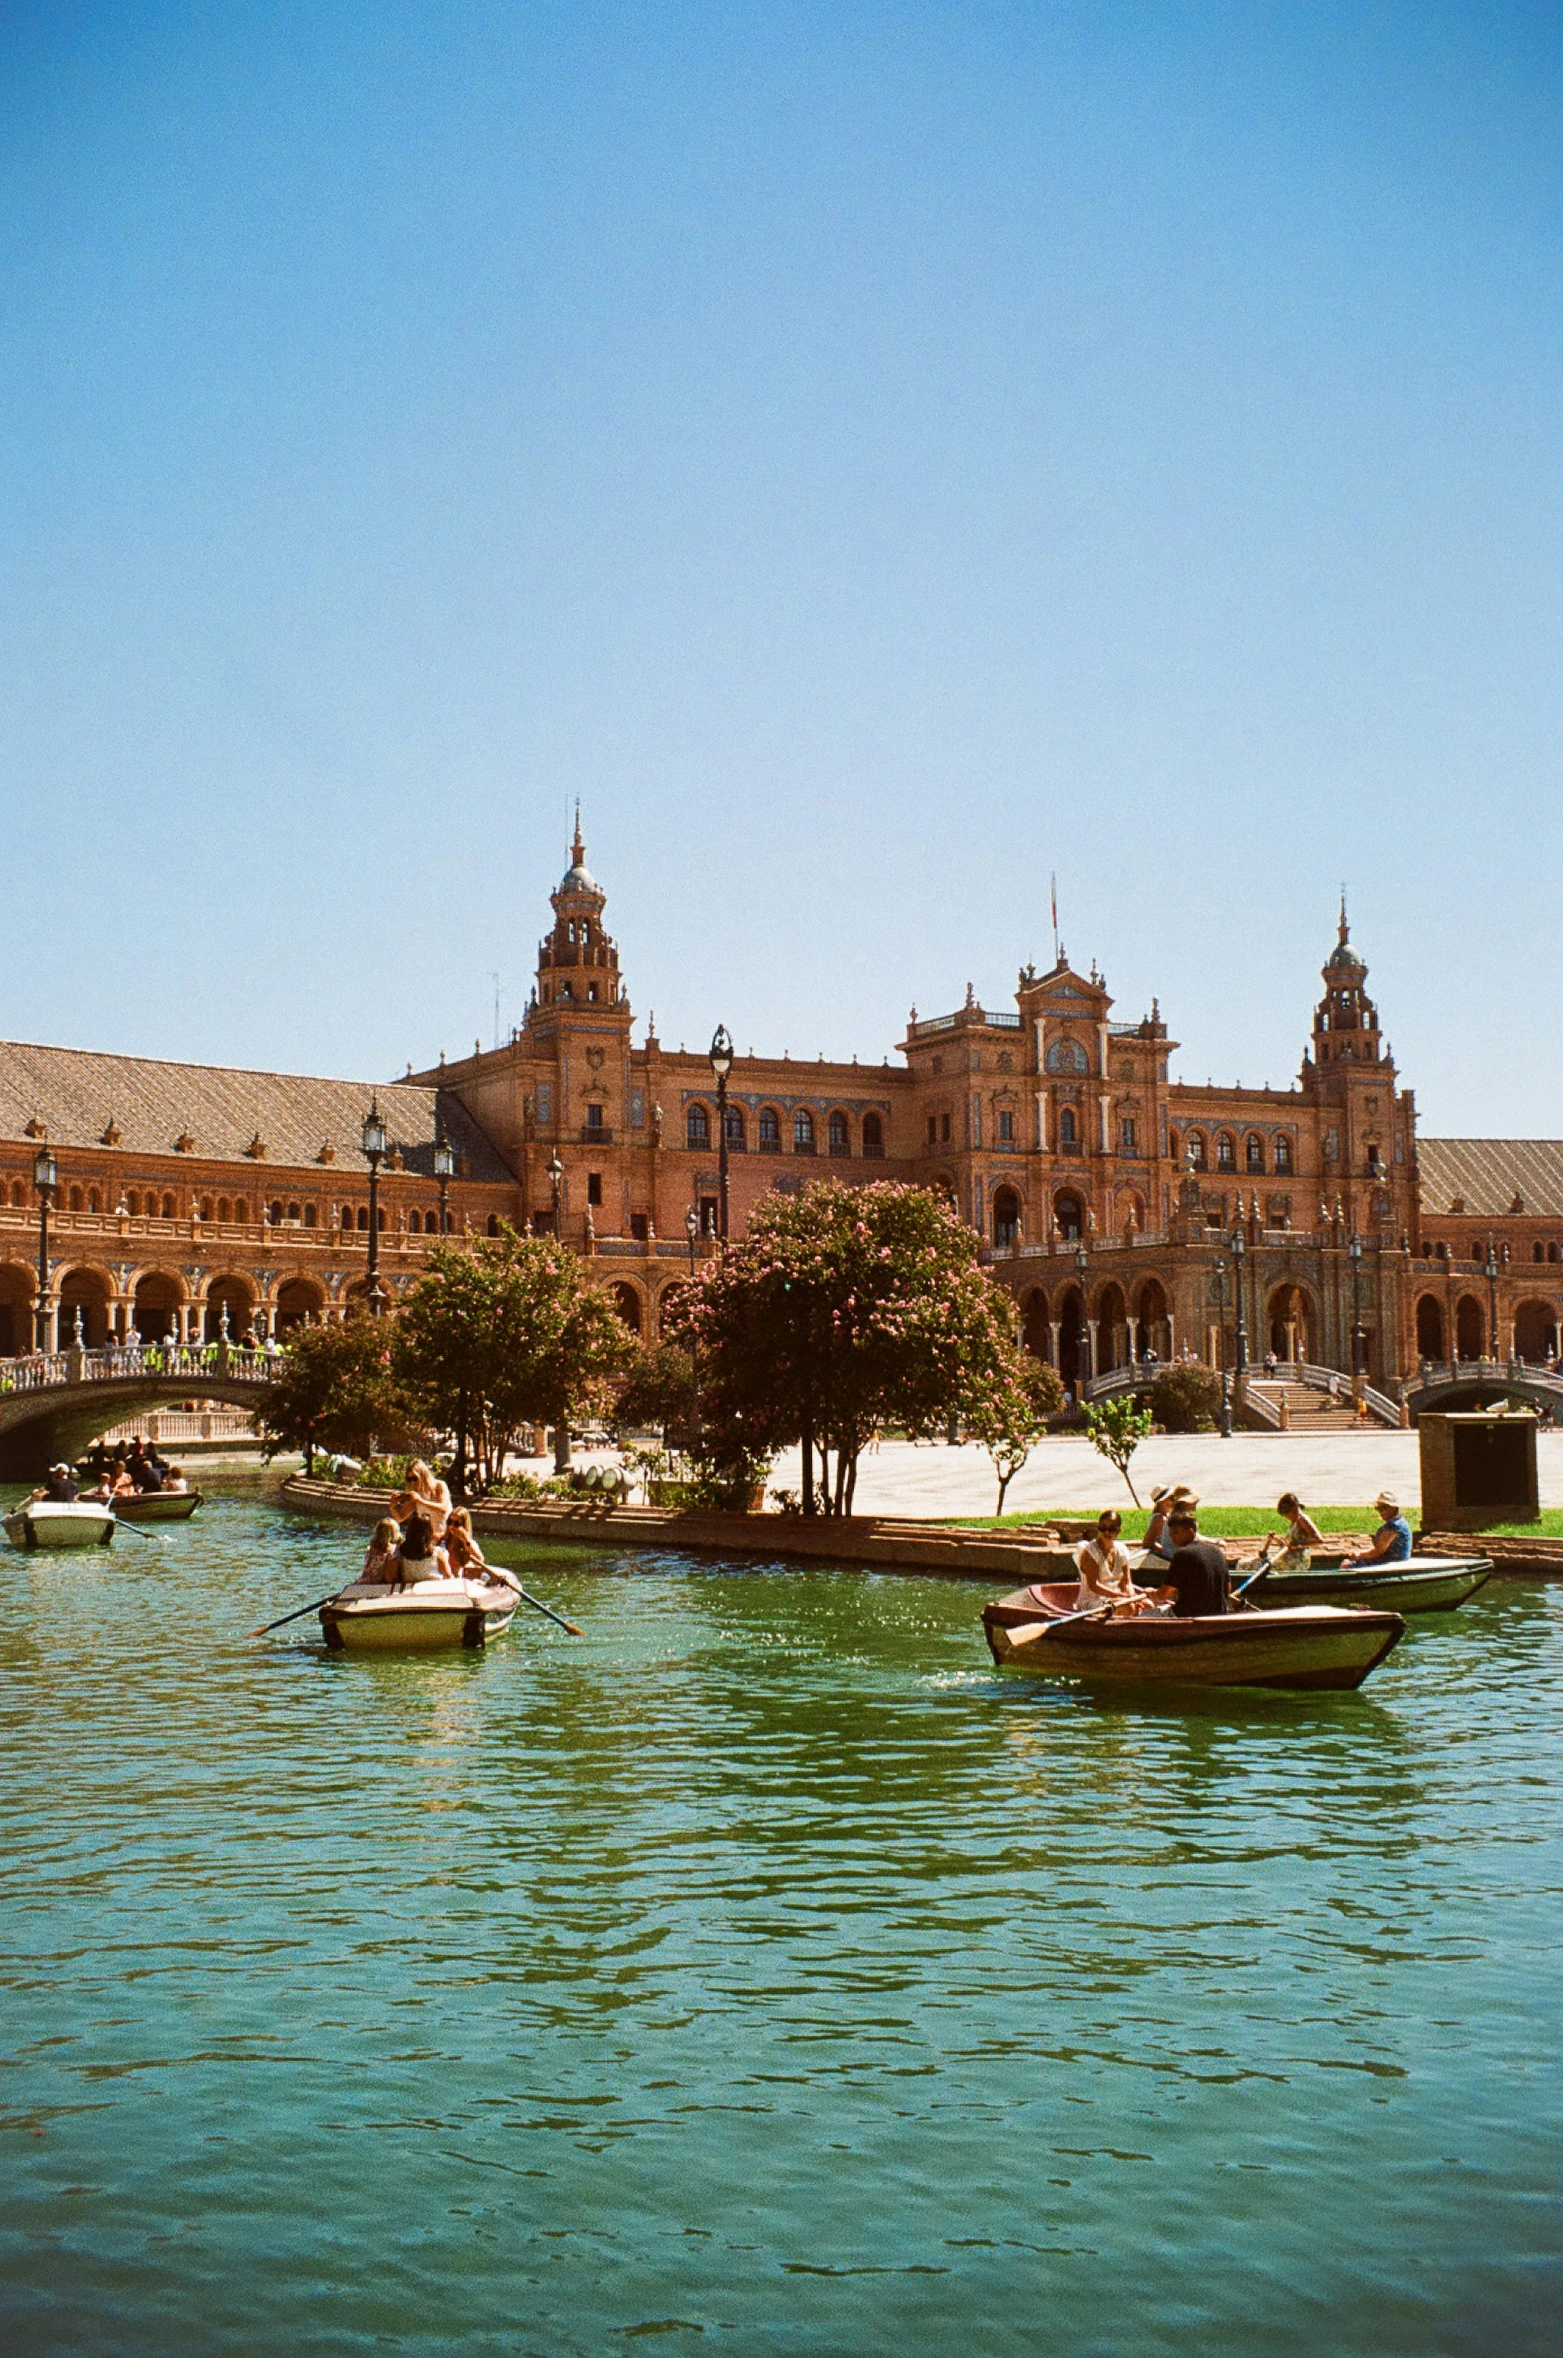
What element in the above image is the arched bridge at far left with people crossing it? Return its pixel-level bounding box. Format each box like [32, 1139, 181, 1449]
[0, 1344, 271, 1481]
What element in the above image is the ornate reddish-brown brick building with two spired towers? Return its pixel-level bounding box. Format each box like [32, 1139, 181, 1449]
[0, 830, 1563, 1387]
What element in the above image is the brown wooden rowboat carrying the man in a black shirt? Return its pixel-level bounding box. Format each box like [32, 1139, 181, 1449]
[983, 1582, 1405, 1686]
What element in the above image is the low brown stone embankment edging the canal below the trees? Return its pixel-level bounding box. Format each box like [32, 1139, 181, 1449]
[283, 1474, 1075, 1582]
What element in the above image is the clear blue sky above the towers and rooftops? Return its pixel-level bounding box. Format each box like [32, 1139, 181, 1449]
[0, 0, 1563, 1134]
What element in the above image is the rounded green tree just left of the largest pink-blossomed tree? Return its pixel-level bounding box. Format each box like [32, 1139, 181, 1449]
[391, 1226, 629, 1488]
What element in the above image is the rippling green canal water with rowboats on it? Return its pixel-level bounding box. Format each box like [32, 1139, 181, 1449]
[0, 1497, 1563, 2358]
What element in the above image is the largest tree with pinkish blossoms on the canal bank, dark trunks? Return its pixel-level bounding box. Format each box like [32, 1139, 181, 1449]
[674, 1179, 1014, 1514]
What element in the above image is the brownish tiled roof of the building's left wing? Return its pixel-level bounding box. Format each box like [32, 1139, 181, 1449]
[0, 1040, 512, 1179]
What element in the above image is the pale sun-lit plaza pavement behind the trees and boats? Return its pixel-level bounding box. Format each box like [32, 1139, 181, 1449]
[771, 1429, 1563, 1516]
